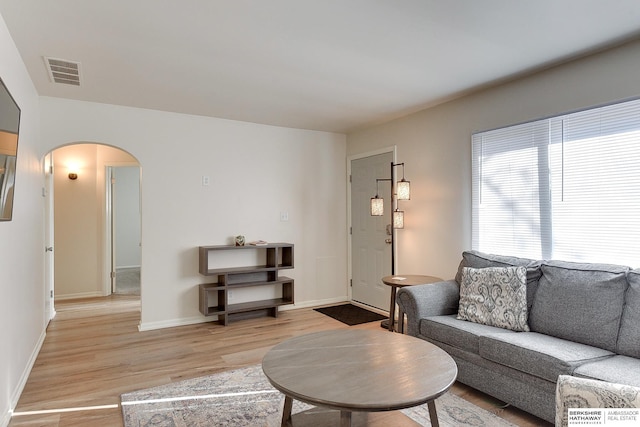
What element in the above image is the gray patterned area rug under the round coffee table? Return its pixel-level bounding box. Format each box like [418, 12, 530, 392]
[121, 365, 515, 427]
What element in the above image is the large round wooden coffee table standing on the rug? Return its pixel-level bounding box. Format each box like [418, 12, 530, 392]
[262, 329, 458, 427]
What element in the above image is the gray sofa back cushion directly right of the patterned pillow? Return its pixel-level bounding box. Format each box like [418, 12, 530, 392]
[529, 261, 628, 351]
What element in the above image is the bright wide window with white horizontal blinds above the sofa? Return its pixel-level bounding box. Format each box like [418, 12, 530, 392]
[472, 100, 640, 267]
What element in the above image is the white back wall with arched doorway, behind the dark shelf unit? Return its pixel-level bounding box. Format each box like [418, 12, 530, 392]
[41, 97, 347, 329]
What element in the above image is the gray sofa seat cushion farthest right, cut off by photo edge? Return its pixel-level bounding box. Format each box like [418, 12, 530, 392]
[573, 356, 640, 387]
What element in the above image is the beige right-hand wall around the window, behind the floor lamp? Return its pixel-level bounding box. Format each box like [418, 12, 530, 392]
[347, 41, 640, 278]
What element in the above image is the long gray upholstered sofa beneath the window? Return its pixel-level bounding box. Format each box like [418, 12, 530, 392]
[397, 251, 640, 422]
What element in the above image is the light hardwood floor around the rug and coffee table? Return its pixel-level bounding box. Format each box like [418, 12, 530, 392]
[9, 296, 551, 427]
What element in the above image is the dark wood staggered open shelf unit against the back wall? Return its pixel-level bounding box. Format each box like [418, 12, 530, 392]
[198, 243, 294, 325]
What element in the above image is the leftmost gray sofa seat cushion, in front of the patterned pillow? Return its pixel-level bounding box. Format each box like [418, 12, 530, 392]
[420, 314, 515, 354]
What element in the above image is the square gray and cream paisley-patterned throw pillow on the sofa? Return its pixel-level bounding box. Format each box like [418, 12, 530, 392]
[458, 267, 529, 332]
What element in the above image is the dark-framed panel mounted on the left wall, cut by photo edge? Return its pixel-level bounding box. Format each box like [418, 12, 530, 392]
[0, 79, 20, 221]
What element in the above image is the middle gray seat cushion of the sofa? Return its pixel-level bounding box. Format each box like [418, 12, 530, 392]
[479, 332, 614, 383]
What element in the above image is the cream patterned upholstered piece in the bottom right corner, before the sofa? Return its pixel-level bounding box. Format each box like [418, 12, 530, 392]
[556, 375, 640, 427]
